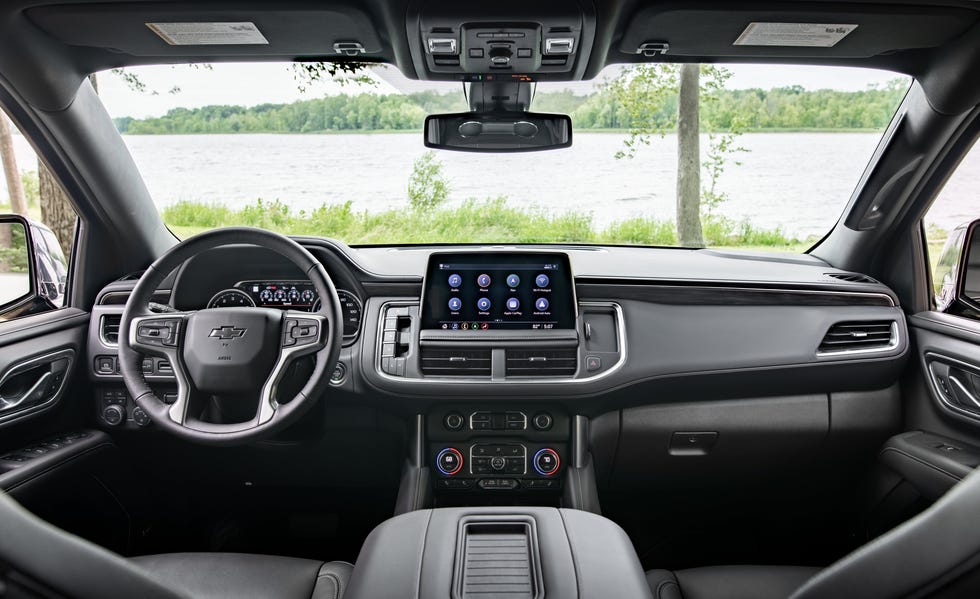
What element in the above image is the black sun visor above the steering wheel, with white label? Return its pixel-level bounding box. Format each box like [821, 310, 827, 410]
[27, 2, 384, 58]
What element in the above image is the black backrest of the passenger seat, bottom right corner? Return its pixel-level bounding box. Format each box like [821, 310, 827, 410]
[791, 470, 980, 599]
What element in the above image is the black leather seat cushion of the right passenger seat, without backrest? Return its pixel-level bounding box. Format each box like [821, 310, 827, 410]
[647, 566, 820, 599]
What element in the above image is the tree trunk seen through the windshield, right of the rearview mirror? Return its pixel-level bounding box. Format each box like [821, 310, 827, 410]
[677, 64, 704, 248]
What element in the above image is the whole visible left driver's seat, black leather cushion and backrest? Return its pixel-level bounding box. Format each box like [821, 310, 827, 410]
[0, 492, 353, 599]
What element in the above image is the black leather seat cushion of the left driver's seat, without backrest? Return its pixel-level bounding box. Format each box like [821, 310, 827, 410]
[131, 553, 353, 599]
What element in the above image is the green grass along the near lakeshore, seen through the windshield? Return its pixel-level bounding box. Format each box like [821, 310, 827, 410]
[163, 198, 813, 252]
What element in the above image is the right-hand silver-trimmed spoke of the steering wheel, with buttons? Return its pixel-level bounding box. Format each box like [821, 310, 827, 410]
[256, 310, 330, 425]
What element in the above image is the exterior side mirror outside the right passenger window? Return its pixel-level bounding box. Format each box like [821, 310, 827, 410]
[933, 220, 980, 318]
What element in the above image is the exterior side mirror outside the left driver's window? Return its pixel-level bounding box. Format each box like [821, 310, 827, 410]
[0, 214, 68, 321]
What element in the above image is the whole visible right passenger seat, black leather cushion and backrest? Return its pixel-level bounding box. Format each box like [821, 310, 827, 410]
[647, 470, 980, 599]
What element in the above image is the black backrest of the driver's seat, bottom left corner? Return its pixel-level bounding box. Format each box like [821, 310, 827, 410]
[0, 493, 183, 599]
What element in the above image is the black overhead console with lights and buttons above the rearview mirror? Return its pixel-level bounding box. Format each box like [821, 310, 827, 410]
[406, 0, 595, 81]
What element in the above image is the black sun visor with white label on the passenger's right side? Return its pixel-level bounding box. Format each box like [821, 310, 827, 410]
[618, 3, 978, 59]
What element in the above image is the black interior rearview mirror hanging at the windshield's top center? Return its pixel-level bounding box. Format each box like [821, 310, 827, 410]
[425, 112, 572, 152]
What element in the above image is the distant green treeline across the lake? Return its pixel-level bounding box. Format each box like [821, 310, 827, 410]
[115, 80, 907, 135]
